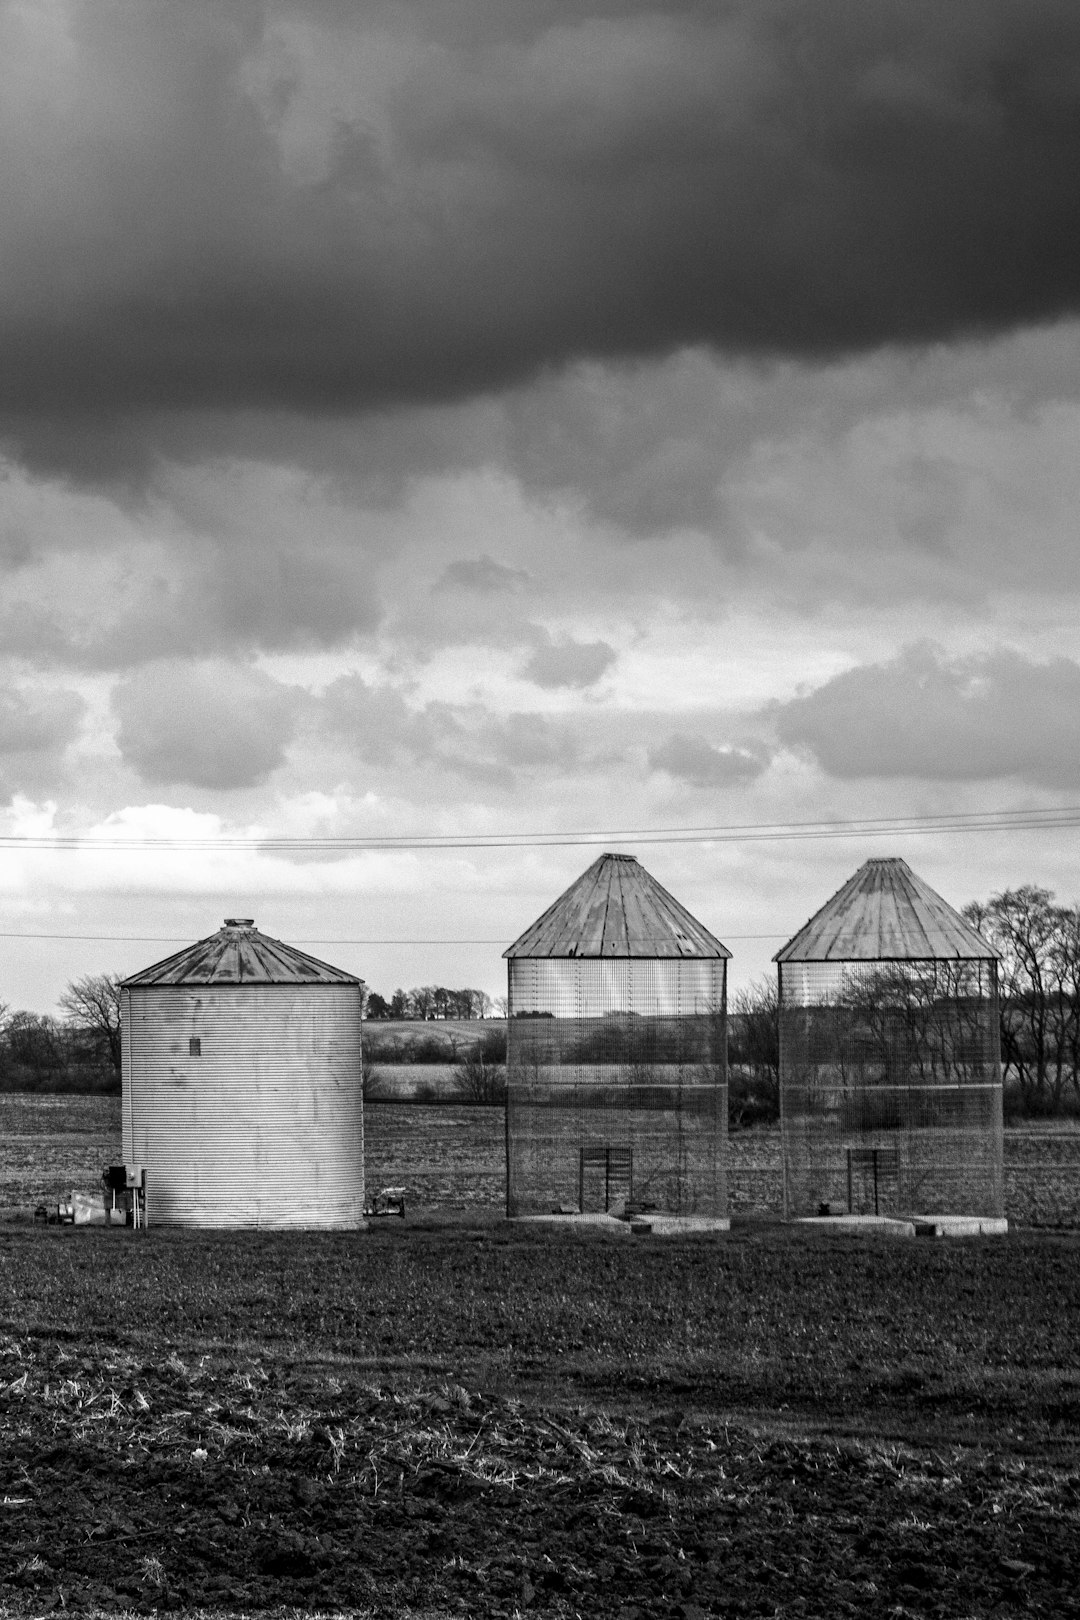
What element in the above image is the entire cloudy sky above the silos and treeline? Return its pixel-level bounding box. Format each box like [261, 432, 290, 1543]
[0, 0, 1080, 1011]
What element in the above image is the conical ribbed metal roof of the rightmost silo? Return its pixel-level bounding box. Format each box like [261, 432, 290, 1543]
[772, 855, 997, 962]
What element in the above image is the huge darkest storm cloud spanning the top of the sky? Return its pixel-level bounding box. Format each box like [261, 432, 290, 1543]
[0, 0, 1080, 443]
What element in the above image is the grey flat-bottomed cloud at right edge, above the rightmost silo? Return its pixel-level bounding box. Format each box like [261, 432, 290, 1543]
[772, 645, 1080, 787]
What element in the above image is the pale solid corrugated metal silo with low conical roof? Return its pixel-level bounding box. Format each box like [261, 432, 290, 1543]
[121, 917, 364, 1226]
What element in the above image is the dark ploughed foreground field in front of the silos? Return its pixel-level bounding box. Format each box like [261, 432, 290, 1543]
[0, 1217, 1080, 1620]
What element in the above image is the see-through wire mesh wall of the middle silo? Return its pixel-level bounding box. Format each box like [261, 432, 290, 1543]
[507, 956, 727, 1218]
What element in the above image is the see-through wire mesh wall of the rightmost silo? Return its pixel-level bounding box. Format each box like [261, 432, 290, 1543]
[779, 961, 1004, 1217]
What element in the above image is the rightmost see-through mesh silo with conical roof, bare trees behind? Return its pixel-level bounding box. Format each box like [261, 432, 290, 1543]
[776, 859, 1004, 1221]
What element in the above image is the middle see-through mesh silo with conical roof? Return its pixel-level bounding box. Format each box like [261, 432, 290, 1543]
[504, 855, 730, 1218]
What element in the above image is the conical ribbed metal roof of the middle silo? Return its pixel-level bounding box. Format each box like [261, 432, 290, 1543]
[502, 855, 732, 957]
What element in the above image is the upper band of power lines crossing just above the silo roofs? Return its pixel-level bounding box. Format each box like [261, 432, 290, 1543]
[0, 805, 1080, 854]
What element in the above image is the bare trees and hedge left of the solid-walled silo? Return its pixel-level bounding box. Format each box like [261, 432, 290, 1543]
[0, 974, 120, 1092]
